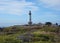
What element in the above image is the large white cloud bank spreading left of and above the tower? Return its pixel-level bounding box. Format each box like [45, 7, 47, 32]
[0, 0, 38, 15]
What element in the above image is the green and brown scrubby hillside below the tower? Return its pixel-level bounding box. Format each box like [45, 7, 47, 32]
[0, 25, 60, 43]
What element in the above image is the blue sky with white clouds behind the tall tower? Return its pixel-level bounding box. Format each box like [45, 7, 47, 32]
[0, 0, 60, 27]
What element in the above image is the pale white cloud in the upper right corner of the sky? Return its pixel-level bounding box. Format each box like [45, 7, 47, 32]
[39, 0, 60, 10]
